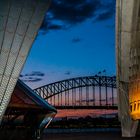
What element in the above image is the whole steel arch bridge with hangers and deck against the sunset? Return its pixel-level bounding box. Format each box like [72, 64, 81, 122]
[34, 75, 117, 109]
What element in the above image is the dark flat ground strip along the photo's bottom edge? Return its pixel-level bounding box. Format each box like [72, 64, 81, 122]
[42, 132, 140, 140]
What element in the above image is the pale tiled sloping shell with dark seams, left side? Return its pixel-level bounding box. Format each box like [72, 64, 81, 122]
[0, 0, 49, 121]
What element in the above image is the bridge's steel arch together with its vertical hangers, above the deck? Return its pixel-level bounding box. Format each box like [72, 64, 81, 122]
[34, 75, 116, 109]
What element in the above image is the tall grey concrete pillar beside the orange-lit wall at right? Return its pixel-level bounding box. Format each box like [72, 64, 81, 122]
[116, 0, 140, 137]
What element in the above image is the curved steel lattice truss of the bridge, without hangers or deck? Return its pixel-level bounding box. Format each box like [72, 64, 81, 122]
[34, 76, 116, 99]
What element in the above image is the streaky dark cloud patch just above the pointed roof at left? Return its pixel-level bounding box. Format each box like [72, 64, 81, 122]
[19, 71, 45, 82]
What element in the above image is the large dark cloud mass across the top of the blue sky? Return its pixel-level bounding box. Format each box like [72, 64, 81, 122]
[41, 0, 115, 32]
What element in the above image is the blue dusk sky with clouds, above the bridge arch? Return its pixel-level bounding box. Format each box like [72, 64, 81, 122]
[20, 0, 116, 88]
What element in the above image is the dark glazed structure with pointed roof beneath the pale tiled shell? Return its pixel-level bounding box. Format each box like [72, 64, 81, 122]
[0, 80, 56, 140]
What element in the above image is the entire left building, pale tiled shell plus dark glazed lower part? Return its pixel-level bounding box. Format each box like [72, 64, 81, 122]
[0, 0, 56, 140]
